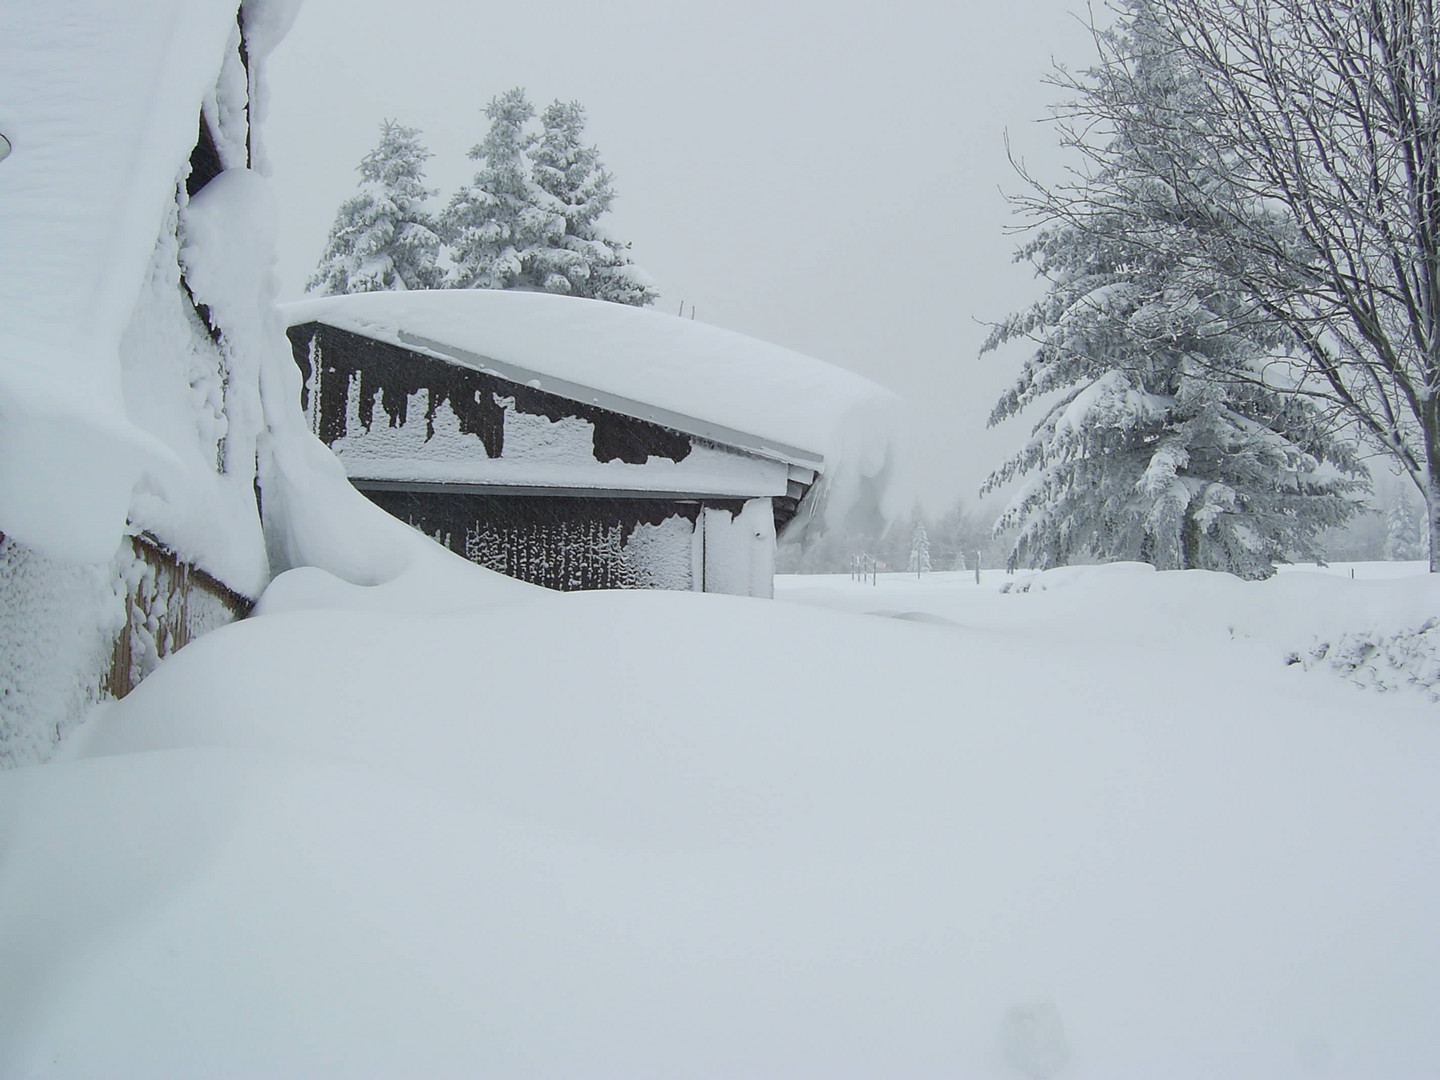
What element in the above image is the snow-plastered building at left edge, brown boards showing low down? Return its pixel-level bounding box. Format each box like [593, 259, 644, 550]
[0, 0, 338, 765]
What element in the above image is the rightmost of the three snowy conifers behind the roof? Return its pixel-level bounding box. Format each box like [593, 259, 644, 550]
[530, 101, 658, 307]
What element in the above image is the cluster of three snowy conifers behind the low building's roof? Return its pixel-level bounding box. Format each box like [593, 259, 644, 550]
[307, 88, 658, 307]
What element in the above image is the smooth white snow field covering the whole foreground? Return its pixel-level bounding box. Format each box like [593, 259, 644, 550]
[0, 560, 1440, 1080]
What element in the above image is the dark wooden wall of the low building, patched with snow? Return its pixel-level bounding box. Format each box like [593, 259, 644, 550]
[288, 323, 814, 590]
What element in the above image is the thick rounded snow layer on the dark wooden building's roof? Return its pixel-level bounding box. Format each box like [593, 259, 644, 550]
[282, 289, 899, 475]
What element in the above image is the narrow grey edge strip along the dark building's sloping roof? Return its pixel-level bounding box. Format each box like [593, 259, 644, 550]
[394, 330, 825, 484]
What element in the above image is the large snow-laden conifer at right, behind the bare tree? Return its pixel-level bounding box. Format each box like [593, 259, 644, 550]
[984, 0, 1364, 577]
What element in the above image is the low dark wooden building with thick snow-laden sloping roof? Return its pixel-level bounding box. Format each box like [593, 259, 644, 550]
[284, 289, 894, 596]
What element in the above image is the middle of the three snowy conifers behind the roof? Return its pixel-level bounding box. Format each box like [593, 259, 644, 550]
[441, 86, 564, 291]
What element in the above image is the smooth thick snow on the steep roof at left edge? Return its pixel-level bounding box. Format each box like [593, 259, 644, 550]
[0, 0, 247, 560]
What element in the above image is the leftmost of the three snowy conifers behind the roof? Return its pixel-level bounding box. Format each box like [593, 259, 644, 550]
[307, 120, 441, 294]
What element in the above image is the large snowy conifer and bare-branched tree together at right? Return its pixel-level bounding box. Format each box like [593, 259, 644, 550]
[985, 0, 1440, 577]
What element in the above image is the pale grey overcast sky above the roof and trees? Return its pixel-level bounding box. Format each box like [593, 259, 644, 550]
[265, 0, 1092, 511]
